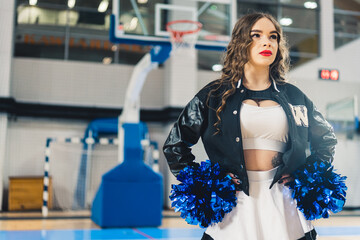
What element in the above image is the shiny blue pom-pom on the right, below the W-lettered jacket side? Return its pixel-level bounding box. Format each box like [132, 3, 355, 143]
[288, 156, 347, 220]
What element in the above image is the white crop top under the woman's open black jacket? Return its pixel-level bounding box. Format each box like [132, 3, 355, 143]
[240, 103, 289, 153]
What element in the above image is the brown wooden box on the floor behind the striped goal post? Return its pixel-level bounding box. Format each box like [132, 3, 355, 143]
[9, 176, 52, 211]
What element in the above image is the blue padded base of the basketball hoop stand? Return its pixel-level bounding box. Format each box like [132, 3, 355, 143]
[91, 124, 163, 228]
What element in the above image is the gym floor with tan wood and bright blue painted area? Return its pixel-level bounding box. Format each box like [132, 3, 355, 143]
[0, 211, 360, 240]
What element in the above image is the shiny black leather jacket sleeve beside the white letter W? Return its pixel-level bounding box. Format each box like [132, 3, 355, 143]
[305, 97, 337, 162]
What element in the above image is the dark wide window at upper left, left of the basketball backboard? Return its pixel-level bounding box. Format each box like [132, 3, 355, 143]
[14, 0, 149, 64]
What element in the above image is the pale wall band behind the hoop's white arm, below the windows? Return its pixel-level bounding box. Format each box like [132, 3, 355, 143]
[11, 58, 164, 109]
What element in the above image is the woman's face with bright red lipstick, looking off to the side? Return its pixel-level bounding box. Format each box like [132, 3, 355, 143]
[247, 17, 279, 67]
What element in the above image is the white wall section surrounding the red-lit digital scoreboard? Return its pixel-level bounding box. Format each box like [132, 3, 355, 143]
[290, 39, 360, 112]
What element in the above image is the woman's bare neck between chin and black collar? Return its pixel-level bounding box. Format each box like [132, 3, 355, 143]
[243, 65, 271, 90]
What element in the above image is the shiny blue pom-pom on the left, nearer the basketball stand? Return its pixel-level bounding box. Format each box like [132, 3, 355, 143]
[170, 160, 237, 228]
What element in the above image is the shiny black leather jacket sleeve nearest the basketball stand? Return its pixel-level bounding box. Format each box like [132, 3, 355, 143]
[163, 96, 205, 176]
